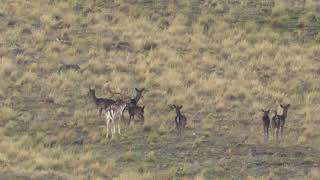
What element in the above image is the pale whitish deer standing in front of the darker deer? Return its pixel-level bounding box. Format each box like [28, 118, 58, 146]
[104, 100, 127, 139]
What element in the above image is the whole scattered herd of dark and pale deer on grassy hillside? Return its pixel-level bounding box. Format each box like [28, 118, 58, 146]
[88, 88, 290, 142]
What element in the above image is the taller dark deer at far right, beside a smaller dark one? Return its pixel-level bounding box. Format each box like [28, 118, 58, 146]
[272, 104, 290, 141]
